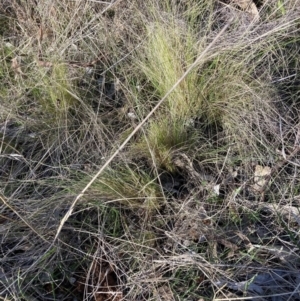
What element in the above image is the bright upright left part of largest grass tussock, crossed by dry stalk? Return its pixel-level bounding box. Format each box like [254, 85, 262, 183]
[127, 5, 202, 172]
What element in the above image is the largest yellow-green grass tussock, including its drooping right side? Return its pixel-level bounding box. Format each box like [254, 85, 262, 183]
[129, 0, 282, 171]
